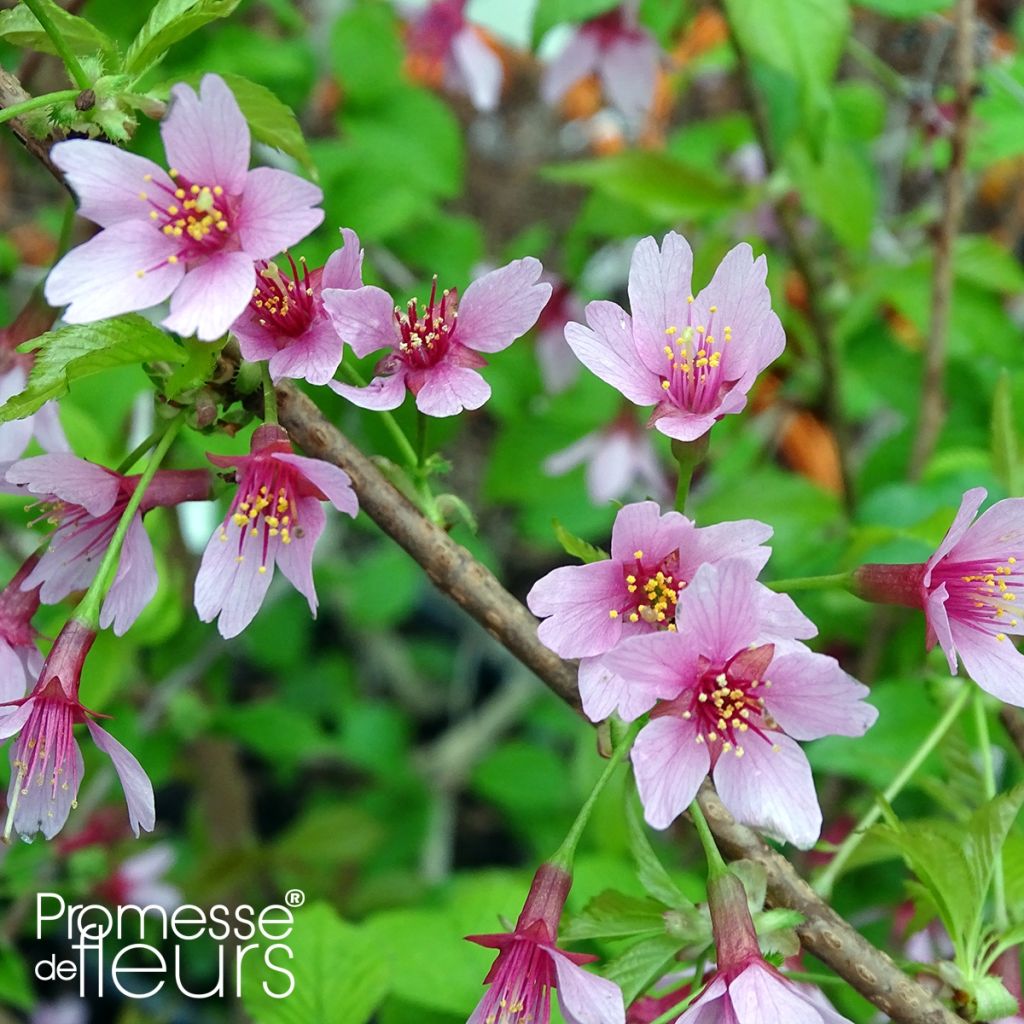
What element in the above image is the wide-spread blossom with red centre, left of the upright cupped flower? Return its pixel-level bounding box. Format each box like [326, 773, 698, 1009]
[324, 256, 551, 416]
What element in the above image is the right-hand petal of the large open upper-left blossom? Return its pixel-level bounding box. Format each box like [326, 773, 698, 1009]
[238, 167, 324, 259]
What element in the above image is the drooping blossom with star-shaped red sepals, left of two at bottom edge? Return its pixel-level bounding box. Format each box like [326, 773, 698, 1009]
[467, 863, 626, 1024]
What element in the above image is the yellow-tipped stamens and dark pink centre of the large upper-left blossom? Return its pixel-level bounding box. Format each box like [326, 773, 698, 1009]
[135, 169, 233, 278]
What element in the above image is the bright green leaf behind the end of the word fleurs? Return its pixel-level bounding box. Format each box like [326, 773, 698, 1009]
[242, 903, 388, 1024]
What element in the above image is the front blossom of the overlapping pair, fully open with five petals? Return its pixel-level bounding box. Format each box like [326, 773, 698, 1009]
[603, 559, 878, 849]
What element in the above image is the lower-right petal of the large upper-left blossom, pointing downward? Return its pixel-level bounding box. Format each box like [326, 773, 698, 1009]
[163, 249, 256, 341]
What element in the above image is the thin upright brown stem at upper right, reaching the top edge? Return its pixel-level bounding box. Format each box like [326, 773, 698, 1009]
[907, 0, 975, 480]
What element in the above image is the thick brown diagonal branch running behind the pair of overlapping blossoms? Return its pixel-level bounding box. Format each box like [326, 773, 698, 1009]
[264, 383, 959, 1024]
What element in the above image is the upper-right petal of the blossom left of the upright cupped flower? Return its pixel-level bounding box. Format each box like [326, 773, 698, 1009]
[456, 256, 551, 352]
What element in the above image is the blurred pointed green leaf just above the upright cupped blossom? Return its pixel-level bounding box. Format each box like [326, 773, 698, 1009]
[541, 150, 739, 221]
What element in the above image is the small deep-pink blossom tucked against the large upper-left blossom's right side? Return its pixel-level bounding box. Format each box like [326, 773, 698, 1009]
[231, 227, 362, 384]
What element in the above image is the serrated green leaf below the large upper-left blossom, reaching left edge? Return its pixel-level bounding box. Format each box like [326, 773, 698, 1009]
[0, 313, 187, 423]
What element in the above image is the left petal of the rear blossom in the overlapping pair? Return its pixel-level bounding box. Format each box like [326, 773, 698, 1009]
[526, 561, 625, 657]
